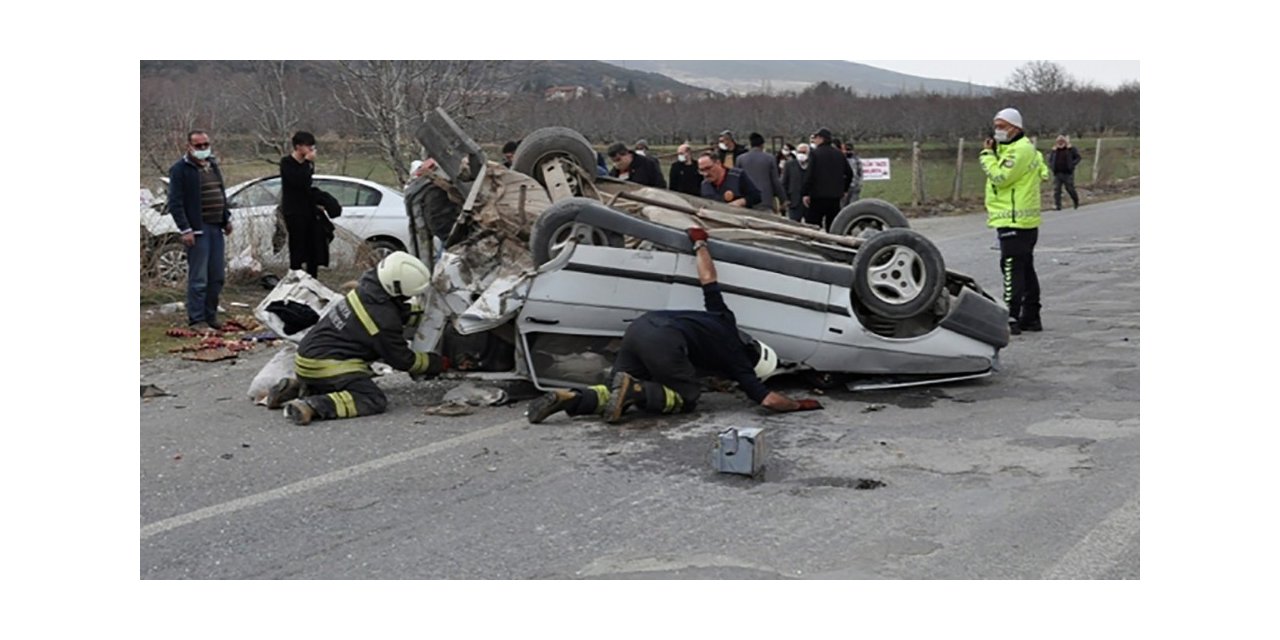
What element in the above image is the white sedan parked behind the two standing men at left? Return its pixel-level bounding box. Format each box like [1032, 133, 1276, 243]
[141, 175, 410, 285]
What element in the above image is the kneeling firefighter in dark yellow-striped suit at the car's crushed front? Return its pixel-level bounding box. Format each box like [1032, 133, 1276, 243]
[266, 251, 449, 425]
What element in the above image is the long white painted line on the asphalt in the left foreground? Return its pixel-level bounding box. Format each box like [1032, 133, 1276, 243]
[142, 417, 527, 540]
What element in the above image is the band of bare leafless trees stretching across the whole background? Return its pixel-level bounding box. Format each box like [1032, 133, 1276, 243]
[140, 60, 1140, 182]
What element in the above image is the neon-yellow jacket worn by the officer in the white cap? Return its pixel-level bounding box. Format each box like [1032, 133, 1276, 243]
[978, 134, 1048, 229]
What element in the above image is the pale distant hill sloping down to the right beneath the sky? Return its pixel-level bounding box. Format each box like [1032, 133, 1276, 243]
[605, 60, 995, 96]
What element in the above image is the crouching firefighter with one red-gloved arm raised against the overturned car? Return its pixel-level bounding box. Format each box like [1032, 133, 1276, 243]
[525, 228, 822, 424]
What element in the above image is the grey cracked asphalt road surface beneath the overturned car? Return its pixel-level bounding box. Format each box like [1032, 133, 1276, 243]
[140, 198, 1140, 579]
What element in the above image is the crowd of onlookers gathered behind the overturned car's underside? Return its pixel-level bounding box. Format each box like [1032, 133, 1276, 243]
[502, 128, 863, 229]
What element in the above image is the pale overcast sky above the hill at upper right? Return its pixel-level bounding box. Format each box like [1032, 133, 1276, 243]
[851, 60, 1140, 88]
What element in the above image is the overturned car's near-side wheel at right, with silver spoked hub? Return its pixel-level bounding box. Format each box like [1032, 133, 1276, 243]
[852, 229, 947, 320]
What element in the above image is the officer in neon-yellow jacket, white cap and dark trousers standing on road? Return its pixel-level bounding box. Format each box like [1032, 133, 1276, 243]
[978, 108, 1048, 335]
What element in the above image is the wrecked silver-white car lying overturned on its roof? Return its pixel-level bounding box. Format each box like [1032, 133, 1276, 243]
[406, 113, 1009, 388]
